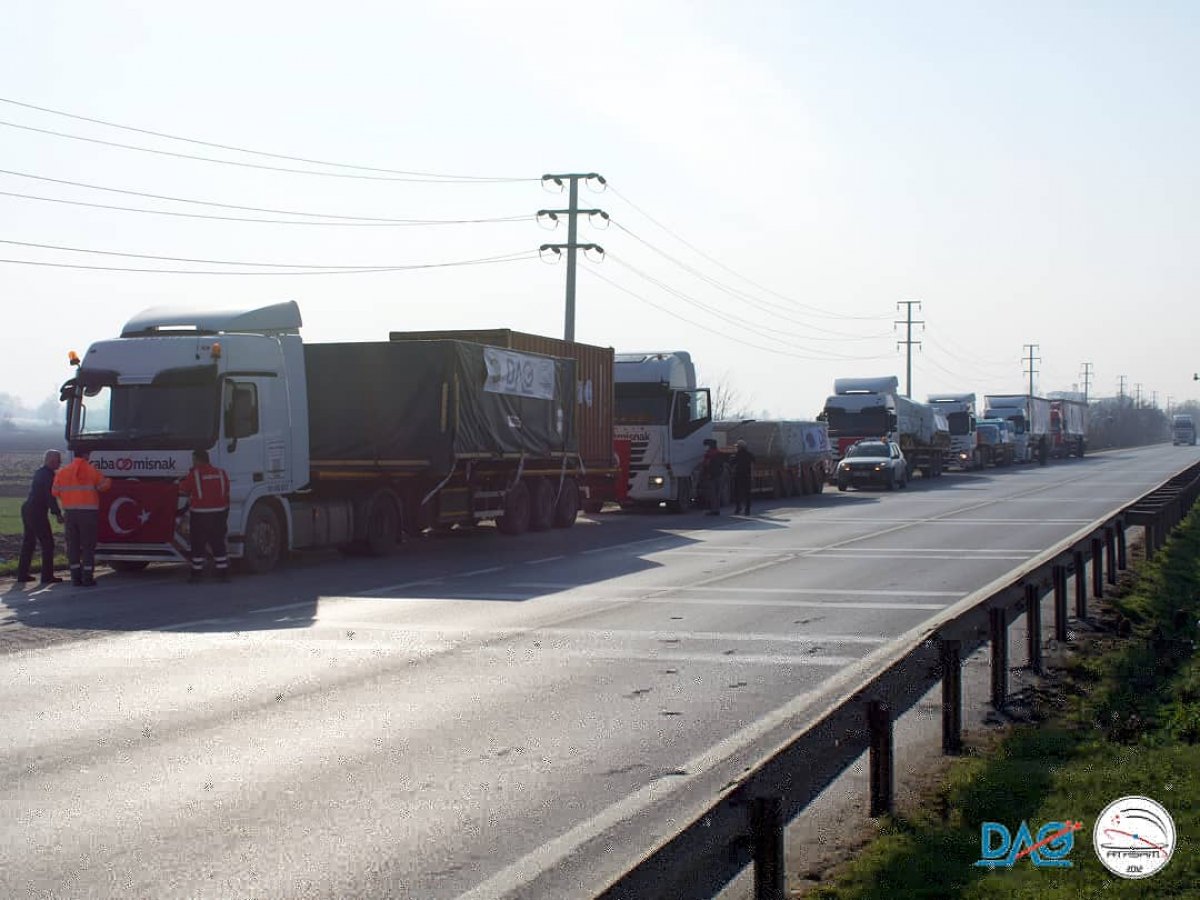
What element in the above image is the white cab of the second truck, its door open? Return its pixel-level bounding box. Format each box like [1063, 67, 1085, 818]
[613, 350, 713, 510]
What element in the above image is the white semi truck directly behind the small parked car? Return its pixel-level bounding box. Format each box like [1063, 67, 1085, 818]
[821, 376, 950, 478]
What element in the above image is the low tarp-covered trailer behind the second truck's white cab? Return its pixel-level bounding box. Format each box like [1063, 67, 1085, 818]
[713, 419, 834, 498]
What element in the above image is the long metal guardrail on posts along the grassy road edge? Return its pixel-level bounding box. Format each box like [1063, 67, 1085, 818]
[599, 463, 1200, 900]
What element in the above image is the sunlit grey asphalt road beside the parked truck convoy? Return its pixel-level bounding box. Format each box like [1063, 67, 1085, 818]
[0, 446, 1195, 900]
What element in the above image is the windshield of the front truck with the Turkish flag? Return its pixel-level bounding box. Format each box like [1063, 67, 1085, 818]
[68, 368, 217, 450]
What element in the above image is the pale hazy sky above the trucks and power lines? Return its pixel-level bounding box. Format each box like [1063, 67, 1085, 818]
[0, 0, 1200, 418]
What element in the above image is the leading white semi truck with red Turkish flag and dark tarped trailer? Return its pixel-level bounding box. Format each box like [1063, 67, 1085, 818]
[62, 301, 618, 572]
